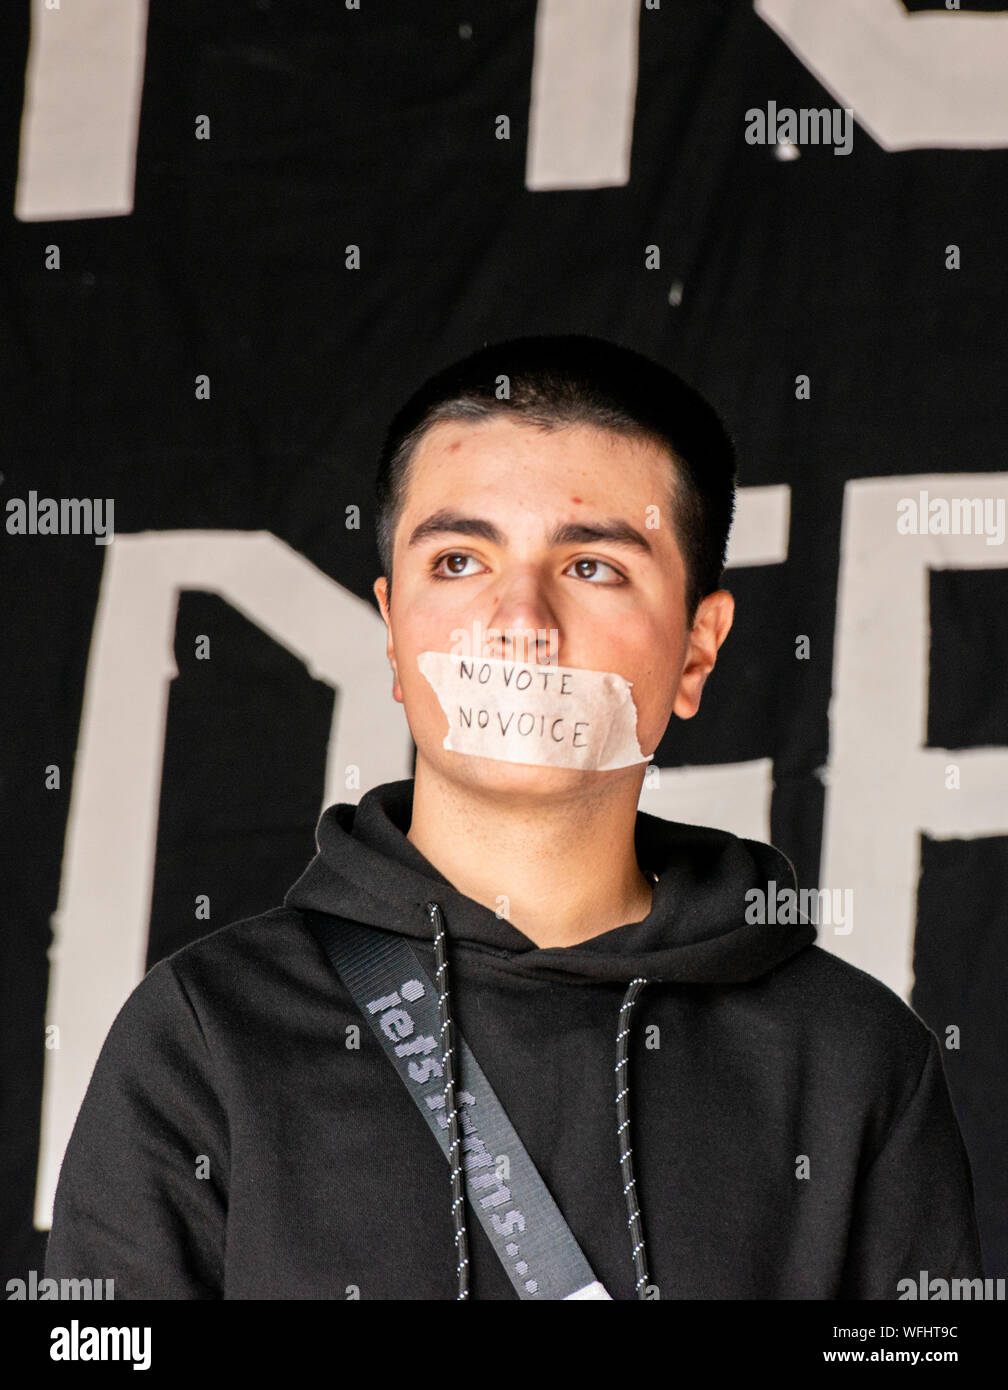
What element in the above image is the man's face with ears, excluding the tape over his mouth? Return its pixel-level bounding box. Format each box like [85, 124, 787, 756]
[374, 417, 731, 792]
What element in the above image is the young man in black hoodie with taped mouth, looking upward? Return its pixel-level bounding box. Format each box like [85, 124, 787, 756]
[46, 336, 983, 1300]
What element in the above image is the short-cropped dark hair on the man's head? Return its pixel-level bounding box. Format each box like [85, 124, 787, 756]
[375, 334, 735, 621]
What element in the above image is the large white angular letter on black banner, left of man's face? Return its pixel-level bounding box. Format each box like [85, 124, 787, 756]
[35, 531, 413, 1229]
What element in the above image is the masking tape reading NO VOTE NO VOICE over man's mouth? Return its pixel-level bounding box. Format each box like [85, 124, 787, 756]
[417, 652, 651, 773]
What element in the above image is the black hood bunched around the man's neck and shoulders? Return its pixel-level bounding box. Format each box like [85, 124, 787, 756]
[284, 778, 816, 984]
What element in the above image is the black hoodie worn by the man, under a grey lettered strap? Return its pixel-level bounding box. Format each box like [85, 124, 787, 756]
[46, 780, 983, 1300]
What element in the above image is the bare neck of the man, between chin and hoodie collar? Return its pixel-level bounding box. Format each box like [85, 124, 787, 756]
[406, 756, 652, 947]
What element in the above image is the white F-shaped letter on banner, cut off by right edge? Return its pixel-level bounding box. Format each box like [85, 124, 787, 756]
[819, 473, 1008, 1002]
